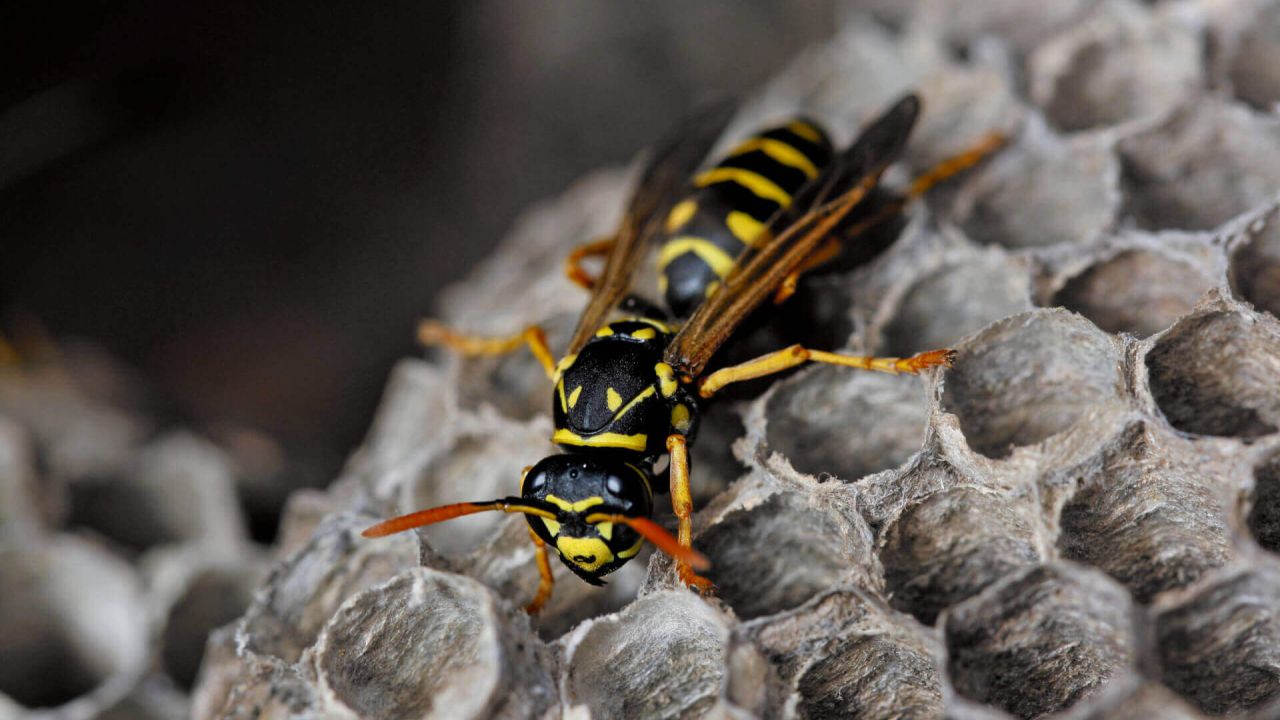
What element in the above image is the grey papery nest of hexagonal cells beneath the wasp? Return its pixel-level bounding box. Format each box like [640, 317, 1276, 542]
[10, 0, 1280, 720]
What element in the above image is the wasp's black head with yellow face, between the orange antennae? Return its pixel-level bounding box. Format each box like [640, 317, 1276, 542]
[521, 455, 653, 584]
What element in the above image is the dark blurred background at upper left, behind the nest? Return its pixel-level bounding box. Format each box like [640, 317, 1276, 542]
[0, 0, 835, 484]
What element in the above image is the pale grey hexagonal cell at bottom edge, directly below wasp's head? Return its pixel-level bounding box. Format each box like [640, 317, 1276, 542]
[561, 591, 764, 717]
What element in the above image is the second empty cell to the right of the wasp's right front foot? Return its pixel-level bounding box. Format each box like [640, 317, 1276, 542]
[881, 487, 1041, 625]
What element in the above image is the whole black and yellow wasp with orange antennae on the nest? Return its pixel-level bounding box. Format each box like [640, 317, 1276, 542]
[365, 95, 1000, 612]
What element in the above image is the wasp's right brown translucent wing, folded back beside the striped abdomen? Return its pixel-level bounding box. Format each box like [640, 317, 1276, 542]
[666, 95, 920, 378]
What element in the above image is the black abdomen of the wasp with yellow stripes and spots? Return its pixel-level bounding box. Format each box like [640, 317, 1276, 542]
[658, 119, 832, 318]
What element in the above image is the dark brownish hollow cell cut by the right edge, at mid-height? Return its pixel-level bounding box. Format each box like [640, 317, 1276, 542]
[1146, 310, 1280, 438]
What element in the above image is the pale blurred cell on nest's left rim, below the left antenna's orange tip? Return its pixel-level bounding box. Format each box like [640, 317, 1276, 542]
[243, 512, 420, 662]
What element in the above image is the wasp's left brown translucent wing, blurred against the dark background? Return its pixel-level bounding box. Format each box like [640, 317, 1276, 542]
[566, 102, 735, 355]
